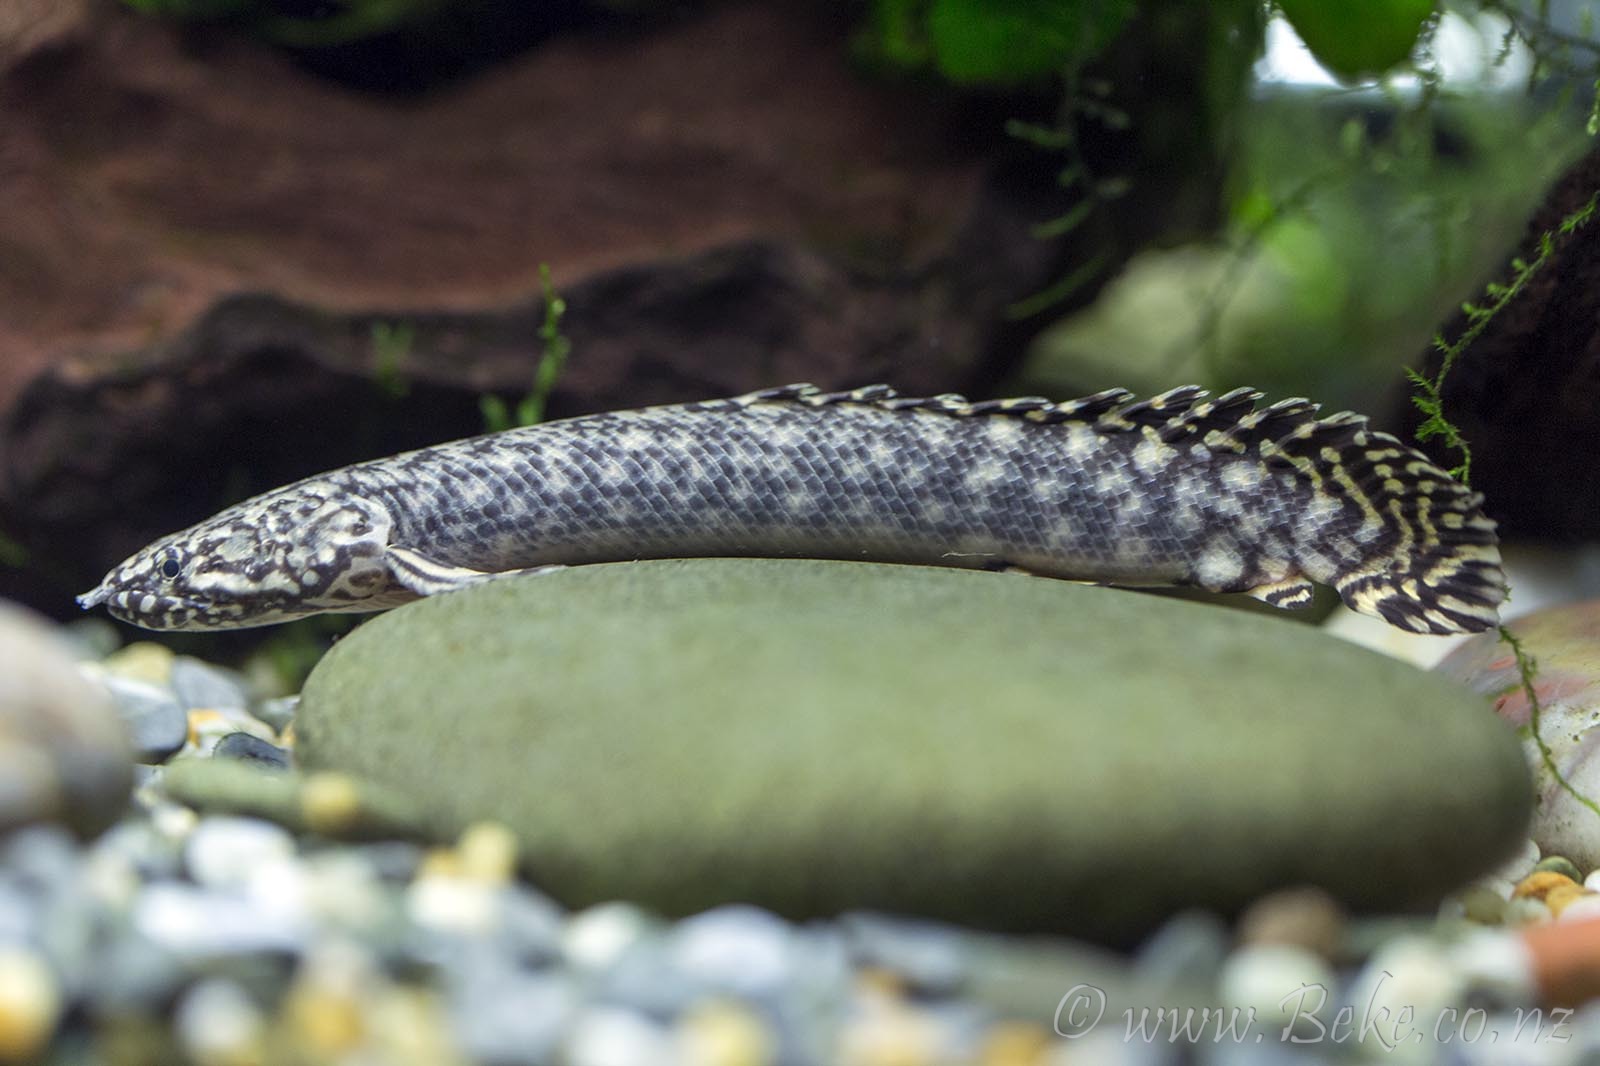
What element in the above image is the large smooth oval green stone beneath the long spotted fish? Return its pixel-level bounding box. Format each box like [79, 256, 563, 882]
[296, 559, 1530, 941]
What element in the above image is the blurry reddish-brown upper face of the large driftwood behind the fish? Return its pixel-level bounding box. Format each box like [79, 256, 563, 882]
[0, 0, 998, 397]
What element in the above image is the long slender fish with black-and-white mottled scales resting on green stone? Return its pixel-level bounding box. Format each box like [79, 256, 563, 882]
[80, 384, 1506, 634]
